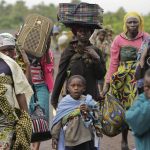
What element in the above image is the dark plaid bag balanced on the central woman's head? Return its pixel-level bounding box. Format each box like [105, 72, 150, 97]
[58, 3, 103, 28]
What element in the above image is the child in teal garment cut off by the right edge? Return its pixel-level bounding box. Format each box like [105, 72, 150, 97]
[126, 69, 150, 150]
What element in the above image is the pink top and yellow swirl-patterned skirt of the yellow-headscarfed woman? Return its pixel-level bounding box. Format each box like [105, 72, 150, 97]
[106, 33, 149, 109]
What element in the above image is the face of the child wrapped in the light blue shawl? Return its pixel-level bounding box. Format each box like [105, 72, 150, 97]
[67, 78, 85, 100]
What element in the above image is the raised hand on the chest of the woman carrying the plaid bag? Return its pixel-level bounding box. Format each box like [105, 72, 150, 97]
[85, 46, 100, 61]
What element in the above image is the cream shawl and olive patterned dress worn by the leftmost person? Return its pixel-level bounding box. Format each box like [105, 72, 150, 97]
[0, 53, 32, 150]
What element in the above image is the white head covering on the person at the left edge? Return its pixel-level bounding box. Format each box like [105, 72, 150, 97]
[0, 33, 15, 50]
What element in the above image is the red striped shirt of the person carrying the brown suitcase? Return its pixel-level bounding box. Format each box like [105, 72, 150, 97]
[31, 64, 44, 84]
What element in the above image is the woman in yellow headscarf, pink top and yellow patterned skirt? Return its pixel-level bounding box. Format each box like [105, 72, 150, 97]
[103, 12, 148, 150]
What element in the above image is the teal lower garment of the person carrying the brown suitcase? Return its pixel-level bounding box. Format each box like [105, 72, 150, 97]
[29, 83, 50, 120]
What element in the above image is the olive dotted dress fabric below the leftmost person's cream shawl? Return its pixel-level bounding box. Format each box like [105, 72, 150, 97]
[0, 76, 32, 150]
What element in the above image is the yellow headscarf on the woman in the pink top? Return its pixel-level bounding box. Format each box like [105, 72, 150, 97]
[123, 12, 144, 33]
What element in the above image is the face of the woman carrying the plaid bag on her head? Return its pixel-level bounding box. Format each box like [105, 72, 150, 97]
[77, 27, 92, 42]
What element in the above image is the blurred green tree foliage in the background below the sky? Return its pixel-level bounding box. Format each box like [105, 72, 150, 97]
[0, 0, 150, 34]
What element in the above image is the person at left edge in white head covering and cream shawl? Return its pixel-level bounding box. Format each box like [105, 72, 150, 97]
[0, 34, 33, 150]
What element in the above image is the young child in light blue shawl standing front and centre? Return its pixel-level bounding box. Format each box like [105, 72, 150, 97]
[51, 75, 101, 150]
